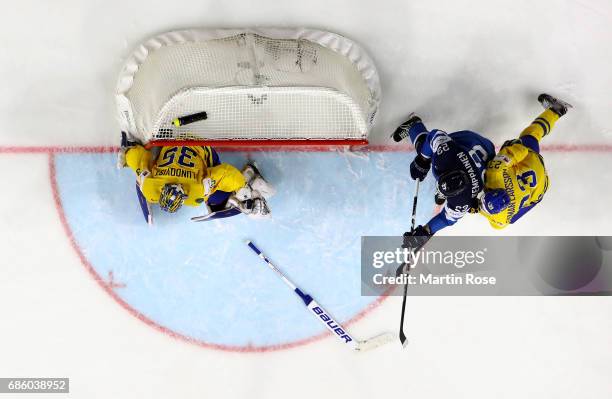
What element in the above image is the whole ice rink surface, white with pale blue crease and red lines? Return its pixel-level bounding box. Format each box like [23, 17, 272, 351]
[0, 0, 612, 399]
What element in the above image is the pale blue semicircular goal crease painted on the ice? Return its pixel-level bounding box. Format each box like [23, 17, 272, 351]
[56, 152, 433, 346]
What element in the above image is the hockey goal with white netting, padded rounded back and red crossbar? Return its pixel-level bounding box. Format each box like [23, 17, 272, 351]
[116, 29, 380, 147]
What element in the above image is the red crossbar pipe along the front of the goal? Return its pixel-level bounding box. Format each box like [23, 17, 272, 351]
[145, 139, 368, 149]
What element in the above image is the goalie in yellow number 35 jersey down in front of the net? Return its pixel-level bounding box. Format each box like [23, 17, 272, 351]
[119, 136, 274, 218]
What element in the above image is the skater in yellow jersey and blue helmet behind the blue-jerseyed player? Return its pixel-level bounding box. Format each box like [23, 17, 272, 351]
[479, 94, 571, 229]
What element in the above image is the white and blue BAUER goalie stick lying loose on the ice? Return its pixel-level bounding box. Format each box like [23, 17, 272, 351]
[246, 241, 393, 351]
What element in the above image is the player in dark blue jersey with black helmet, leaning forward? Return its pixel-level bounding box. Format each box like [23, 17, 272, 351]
[393, 114, 495, 248]
